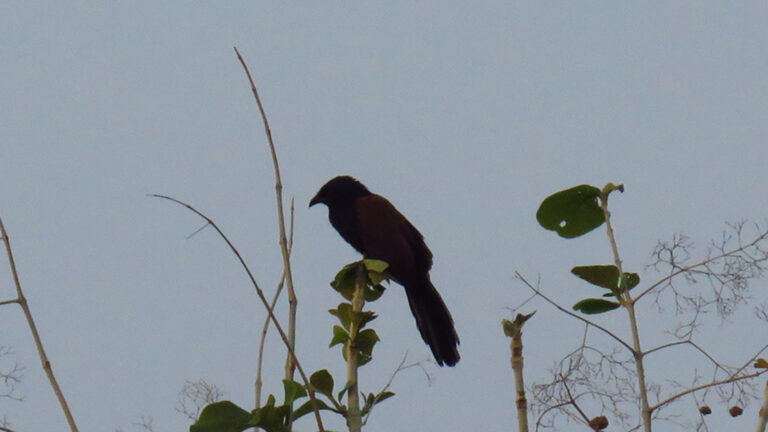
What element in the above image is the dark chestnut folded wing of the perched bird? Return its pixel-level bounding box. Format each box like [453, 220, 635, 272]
[355, 195, 432, 281]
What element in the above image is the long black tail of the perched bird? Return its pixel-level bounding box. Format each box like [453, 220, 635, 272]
[404, 275, 460, 366]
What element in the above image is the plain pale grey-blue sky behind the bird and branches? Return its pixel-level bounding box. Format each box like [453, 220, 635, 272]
[0, 0, 768, 432]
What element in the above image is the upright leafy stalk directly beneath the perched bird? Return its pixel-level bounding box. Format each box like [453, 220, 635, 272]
[344, 263, 368, 432]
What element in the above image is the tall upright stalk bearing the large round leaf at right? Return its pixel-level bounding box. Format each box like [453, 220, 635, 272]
[600, 192, 652, 432]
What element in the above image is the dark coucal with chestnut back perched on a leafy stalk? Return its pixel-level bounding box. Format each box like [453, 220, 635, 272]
[309, 176, 459, 366]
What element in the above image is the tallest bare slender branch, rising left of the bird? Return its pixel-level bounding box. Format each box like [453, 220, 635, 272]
[235, 47, 298, 388]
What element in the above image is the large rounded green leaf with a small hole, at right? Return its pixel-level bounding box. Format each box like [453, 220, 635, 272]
[536, 185, 605, 238]
